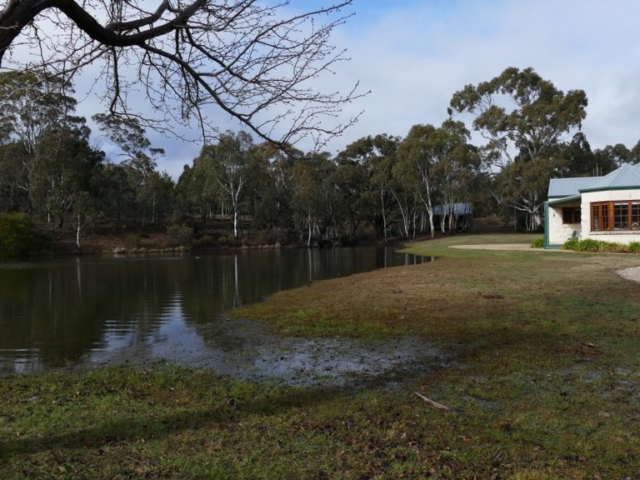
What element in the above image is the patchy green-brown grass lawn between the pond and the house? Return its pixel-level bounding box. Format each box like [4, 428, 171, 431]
[0, 235, 640, 480]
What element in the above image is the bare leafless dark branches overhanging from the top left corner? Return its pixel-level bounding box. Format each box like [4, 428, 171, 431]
[0, 0, 361, 143]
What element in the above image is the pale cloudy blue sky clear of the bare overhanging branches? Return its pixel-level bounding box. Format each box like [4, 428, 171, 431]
[66, 0, 640, 179]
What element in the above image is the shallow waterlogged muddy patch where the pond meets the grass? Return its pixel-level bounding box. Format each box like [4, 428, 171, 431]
[81, 317, 453, 387]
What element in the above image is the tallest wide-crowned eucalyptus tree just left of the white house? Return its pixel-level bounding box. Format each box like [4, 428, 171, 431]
[449, 67, 587, 228]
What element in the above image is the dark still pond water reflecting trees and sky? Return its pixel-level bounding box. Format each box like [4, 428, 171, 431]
[0, 247, 429, 373]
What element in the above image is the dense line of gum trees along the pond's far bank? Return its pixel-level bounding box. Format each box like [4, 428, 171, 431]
[0, 68, 640, 247]
